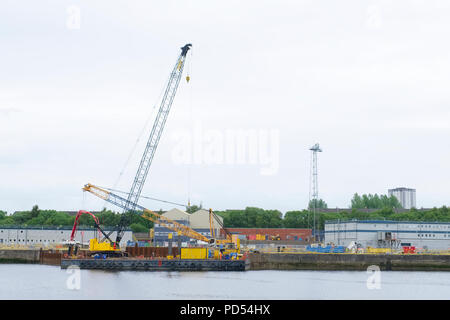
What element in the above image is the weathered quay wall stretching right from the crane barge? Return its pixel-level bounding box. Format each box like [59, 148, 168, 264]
[249, 253, 450, 271]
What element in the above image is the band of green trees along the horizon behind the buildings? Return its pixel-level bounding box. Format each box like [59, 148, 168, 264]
[0, 201, 450, 232]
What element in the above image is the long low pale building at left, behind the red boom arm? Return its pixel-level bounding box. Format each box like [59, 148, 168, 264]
[0, 226, 133, 246]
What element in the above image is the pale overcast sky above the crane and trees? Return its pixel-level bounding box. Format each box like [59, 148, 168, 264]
[0, 0, 450, 212]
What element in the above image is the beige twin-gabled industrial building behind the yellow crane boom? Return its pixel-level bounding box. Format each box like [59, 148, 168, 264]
[153, 209, 223, 245]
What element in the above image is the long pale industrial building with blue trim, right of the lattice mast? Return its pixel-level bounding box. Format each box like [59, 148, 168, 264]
[325, 220, 450, 250]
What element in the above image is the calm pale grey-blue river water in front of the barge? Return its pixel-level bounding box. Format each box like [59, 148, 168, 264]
[0, 264, 450, 300]
